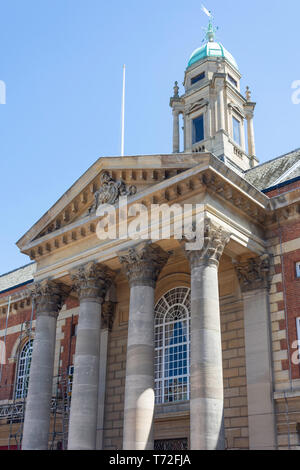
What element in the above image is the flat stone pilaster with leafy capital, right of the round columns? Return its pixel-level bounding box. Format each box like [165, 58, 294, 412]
[236, 255, 276, 450]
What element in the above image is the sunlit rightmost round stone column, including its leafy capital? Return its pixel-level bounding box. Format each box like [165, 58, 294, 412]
[186, 219, 230, 450]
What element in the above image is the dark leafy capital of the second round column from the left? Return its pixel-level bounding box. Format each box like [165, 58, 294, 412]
[70, 261, 114, 303]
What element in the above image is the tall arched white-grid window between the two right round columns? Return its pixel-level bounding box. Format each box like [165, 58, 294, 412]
[155, 287, 191, 403]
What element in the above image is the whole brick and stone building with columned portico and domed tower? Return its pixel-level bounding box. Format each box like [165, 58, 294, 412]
[0, 23, 300, 450]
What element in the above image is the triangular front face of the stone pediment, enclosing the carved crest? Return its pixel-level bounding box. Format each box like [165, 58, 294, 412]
[17, 154, 209, 255]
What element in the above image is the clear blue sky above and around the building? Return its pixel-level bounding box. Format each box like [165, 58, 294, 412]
[0, 0, 300, 273]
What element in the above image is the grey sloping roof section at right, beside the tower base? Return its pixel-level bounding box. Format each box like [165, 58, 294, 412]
[245, 148, 300, 191]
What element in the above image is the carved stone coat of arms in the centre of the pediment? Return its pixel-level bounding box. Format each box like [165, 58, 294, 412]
[89, 171, 137, 214]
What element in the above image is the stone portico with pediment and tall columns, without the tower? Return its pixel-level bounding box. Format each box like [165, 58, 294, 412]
[15, 154, 276, 450]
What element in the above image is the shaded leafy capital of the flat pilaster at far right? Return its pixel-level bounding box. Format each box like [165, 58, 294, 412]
[235, 253, 271, 293]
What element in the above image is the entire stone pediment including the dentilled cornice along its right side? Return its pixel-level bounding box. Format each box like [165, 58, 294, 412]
[17, 153, 270, 260]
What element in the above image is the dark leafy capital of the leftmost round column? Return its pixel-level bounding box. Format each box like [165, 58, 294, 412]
[30, 279, 70, 317]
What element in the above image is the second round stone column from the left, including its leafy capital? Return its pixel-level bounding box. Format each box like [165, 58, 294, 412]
[68, 262, 112, 450]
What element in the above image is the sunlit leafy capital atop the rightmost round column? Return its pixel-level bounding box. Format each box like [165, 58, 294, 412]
[185, 218, 231, 268]
